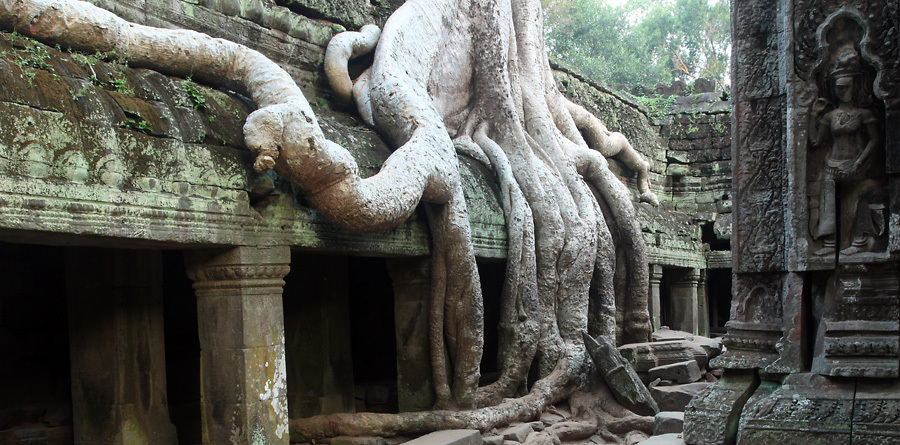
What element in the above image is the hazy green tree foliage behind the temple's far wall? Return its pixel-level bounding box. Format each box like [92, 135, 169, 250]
[543, 0, 731, 90]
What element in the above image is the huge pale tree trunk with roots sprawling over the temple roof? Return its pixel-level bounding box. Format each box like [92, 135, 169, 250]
[0, 0, 650, 437]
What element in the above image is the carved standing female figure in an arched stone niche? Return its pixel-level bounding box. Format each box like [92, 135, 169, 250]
[804, 8, 888, 263]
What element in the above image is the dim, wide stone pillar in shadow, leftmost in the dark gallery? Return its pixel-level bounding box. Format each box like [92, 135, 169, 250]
[65, 248, 178, 445]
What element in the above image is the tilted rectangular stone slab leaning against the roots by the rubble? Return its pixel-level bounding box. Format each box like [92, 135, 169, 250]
[582, 332, 659, 415]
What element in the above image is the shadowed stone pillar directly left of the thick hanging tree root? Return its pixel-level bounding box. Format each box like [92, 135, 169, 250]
[387, 258, 435, 412]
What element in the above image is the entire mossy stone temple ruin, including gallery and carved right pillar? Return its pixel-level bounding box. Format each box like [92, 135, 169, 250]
[0, 0, 900, 444]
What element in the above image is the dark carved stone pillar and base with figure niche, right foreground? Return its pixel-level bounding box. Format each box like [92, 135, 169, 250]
[685, 0, 900, 443]
